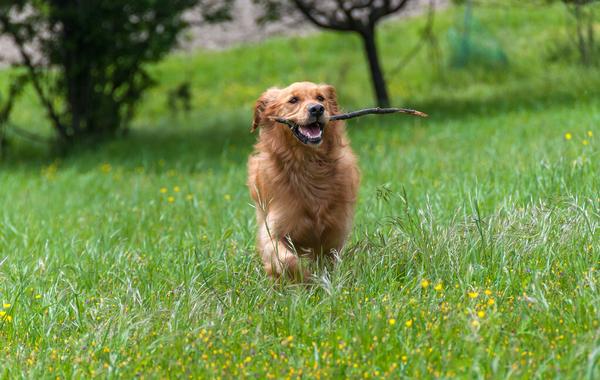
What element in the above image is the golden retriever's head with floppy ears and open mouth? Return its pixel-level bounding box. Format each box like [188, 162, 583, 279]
[251, 82, 338, 146]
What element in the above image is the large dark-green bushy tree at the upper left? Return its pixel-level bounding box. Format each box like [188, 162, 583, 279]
[0, 0, 231, 145]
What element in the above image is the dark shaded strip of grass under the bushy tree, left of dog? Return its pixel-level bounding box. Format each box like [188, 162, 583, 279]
[0, 114, 256, 172]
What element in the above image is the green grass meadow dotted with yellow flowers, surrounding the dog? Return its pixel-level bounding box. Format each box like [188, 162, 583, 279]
[0, 2, 600, 379]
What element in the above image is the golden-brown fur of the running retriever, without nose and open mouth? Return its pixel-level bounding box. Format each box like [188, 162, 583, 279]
[248, 82, 360, 279]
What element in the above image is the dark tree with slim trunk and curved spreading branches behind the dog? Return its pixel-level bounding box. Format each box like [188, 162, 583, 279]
[257, 0, 410, 107]
